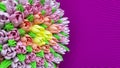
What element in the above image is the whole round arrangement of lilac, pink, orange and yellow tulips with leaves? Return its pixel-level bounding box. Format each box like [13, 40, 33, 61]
[0, 0, 70, 68]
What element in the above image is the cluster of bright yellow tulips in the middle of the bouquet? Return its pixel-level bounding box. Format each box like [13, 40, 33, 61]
[31, 25, 52, 46]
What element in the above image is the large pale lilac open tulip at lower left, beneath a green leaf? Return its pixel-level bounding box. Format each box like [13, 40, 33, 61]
[1, 44, 16, 59]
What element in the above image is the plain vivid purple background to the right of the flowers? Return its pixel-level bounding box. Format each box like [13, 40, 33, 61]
[58, 0, 120, 68]
